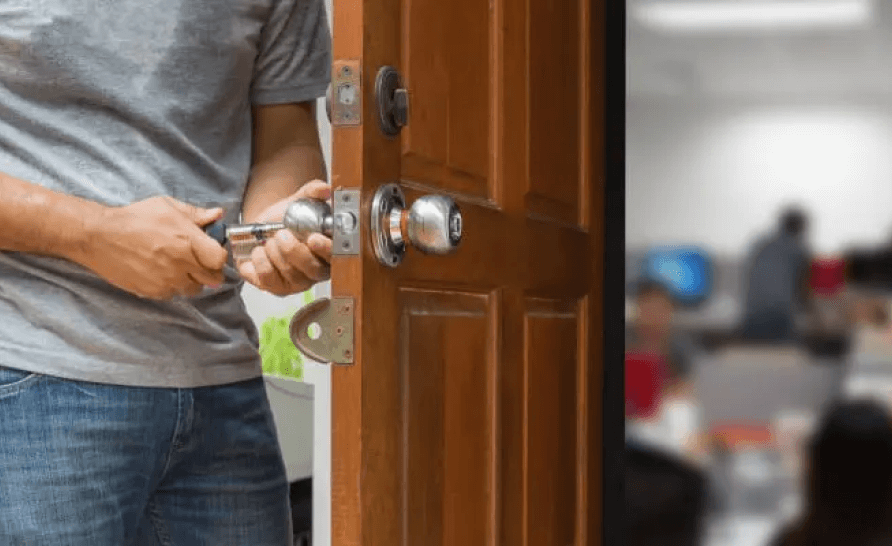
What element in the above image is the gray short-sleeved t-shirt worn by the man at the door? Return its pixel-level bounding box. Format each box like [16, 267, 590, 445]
[0, 0, 331, 388]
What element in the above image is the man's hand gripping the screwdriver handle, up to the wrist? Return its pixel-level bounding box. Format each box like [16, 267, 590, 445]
[77, 197, 228, 300]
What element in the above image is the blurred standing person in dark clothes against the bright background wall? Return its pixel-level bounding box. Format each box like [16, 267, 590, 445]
[743, 209, 811, 342]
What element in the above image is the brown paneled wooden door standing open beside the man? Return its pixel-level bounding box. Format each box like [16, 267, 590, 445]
[332, 0, 603, 546]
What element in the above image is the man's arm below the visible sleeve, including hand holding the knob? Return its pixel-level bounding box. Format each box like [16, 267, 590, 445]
[239, 102, 331, 296]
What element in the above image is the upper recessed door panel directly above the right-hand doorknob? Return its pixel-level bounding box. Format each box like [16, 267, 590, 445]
[401, 0, 492, 197]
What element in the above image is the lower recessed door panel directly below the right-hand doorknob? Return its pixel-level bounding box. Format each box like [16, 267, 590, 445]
[400, 290, 497, 546]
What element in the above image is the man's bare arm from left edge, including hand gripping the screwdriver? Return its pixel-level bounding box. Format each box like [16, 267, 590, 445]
[0, 170, 226, 299]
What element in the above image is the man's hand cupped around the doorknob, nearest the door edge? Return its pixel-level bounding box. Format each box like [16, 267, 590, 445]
[238, 180, 331, 296]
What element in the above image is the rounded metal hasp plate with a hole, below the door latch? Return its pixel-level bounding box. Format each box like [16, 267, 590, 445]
[288, 298, 354, 364]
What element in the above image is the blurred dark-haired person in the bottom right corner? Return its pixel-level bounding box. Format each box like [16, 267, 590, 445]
[771, 401, 892, 546]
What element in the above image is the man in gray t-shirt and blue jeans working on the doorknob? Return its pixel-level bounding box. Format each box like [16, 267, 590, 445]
[0, 0, 331, 546]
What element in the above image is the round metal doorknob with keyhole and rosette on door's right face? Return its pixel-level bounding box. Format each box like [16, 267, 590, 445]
[371, 184, 463, 267]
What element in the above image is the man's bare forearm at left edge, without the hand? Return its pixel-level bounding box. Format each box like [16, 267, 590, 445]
[0, 173, 105, 261]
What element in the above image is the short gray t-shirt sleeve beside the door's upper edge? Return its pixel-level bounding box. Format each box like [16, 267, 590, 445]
[251, 0, 331, 105]
